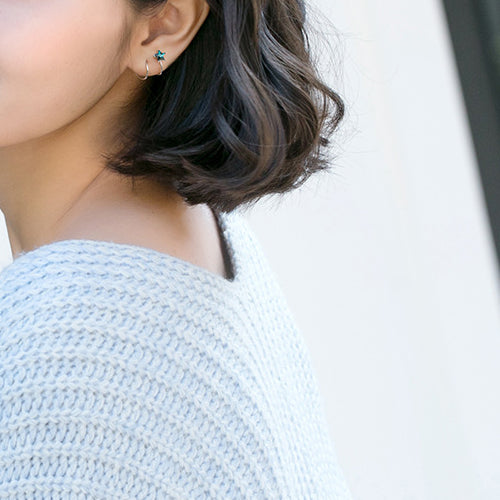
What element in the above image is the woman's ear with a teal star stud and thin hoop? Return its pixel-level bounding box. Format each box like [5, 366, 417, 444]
[128, 0, 210, 75]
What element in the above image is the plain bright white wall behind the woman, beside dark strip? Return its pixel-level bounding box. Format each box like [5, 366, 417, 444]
[240, 0, 500, 500]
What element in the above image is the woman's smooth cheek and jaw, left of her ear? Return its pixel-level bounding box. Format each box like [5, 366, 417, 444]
[0, 0, 129, 147]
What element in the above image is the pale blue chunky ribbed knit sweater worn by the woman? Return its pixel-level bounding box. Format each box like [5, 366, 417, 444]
[0, 211, 351, 500]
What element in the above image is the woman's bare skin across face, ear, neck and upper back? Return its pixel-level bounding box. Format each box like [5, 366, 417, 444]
[0, 0, 227, 276]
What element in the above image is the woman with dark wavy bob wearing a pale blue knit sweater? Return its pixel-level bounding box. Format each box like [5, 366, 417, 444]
[0, 0, 350, 499]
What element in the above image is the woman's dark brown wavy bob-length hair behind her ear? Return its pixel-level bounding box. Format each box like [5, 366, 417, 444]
[104, 0, 344, 212]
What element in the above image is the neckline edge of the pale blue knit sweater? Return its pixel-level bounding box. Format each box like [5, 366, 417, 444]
[8, 210, 244, 290]
